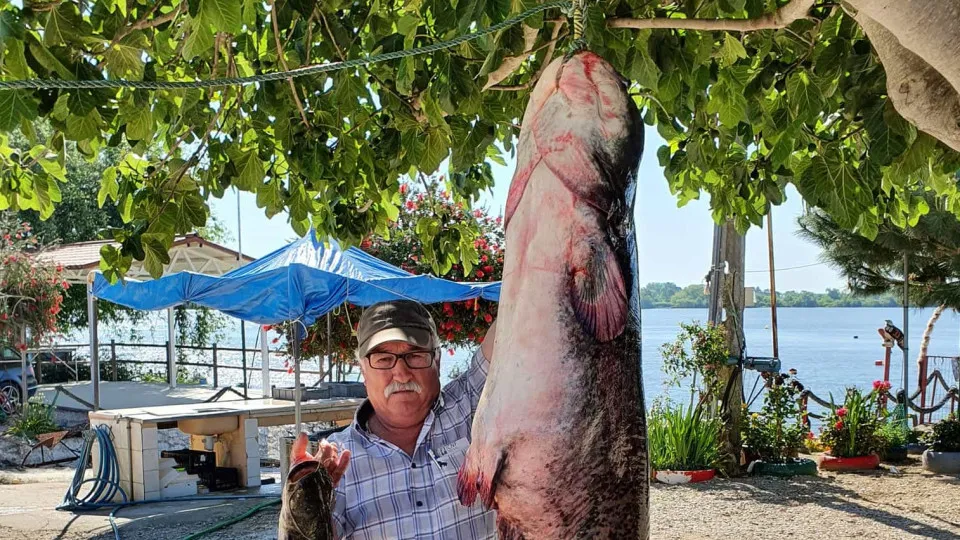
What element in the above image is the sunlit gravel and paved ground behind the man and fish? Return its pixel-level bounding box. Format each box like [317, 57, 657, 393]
[0, 459, 960, 540]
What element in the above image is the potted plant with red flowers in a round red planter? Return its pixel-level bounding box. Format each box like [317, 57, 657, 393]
[820, 388, 881, 471]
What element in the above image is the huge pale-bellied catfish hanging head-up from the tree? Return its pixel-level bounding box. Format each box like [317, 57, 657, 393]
[458, 51, 649, 539]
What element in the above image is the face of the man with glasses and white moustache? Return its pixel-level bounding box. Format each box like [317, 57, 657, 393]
[360, 341, 440, 428]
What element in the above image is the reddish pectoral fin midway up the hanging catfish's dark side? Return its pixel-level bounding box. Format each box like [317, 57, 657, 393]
[571, 242, 627, 342]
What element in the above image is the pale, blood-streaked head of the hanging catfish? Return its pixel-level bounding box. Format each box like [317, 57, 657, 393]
[505, 50, 644, 225]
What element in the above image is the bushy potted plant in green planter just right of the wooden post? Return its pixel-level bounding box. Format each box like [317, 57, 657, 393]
[742, 374, 817, 476]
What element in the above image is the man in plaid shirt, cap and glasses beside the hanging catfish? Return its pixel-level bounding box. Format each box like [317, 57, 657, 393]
[291, 300, 496, 539]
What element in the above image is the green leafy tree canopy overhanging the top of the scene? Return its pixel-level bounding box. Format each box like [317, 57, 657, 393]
[0, 0, 960, 278]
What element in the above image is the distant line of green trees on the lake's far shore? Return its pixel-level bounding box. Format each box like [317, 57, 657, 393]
[640, 283, 901, 309]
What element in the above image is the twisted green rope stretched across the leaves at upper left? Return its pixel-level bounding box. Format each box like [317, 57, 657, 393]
[0, 0, 568, 90]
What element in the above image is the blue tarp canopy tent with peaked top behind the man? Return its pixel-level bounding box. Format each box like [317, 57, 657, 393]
[90, 230, 500, 431]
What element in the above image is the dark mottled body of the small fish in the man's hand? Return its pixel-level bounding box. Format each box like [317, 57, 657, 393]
[277, 461, 336, 540]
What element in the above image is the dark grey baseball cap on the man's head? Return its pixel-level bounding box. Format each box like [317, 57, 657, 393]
[357, 300, 440, 358]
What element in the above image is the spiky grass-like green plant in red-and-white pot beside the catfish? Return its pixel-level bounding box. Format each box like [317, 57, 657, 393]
[647, 402, 723, 484]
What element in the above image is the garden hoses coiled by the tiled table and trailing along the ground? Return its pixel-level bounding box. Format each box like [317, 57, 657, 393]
[56, 426, 280, 540]
